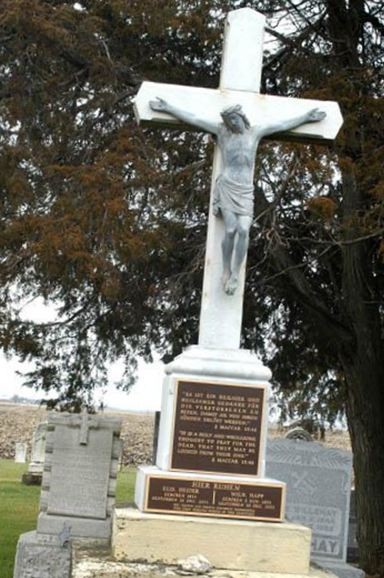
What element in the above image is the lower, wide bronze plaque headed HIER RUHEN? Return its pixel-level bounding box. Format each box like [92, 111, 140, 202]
[145, 476, 284, 522]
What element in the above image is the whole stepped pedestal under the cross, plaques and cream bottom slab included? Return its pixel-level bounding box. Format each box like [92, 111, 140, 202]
[112, 346, 320, 578]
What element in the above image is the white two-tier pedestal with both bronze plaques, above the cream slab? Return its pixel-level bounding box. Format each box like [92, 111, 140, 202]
[135, 346, 285, 522]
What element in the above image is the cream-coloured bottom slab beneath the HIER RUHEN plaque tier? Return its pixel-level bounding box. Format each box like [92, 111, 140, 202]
[112, 508, 311, 575]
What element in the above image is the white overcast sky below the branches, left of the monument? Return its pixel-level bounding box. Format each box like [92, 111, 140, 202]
[0, 299, 164, 411]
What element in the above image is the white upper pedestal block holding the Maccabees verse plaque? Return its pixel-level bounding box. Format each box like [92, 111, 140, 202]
[156, 346, 271, 477]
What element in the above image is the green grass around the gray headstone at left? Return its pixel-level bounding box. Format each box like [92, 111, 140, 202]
[0, 459, 136, 578]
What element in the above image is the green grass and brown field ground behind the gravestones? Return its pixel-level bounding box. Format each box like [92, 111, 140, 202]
[0, 401, 350, 578]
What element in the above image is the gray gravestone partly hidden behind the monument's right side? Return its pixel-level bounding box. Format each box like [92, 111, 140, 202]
[266, 439, 364, 578]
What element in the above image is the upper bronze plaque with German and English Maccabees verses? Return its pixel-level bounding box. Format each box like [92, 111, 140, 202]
[171, 381, 265, 476]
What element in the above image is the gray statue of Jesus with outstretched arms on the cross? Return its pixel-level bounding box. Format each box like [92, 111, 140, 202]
[149, 98, 326, 295]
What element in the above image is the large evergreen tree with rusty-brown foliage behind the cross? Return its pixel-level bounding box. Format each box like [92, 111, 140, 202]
[0, 0, 384, 575]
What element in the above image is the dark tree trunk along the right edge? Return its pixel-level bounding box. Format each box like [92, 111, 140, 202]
[339, 164, 384, 577]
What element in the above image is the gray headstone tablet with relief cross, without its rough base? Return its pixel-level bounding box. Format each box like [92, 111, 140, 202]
[37, 413, 121, 540]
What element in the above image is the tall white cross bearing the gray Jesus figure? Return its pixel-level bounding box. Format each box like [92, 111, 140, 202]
[134, 8, 342, 349]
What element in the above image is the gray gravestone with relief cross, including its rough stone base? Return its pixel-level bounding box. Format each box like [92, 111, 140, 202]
[14, 410, 121, 578]
